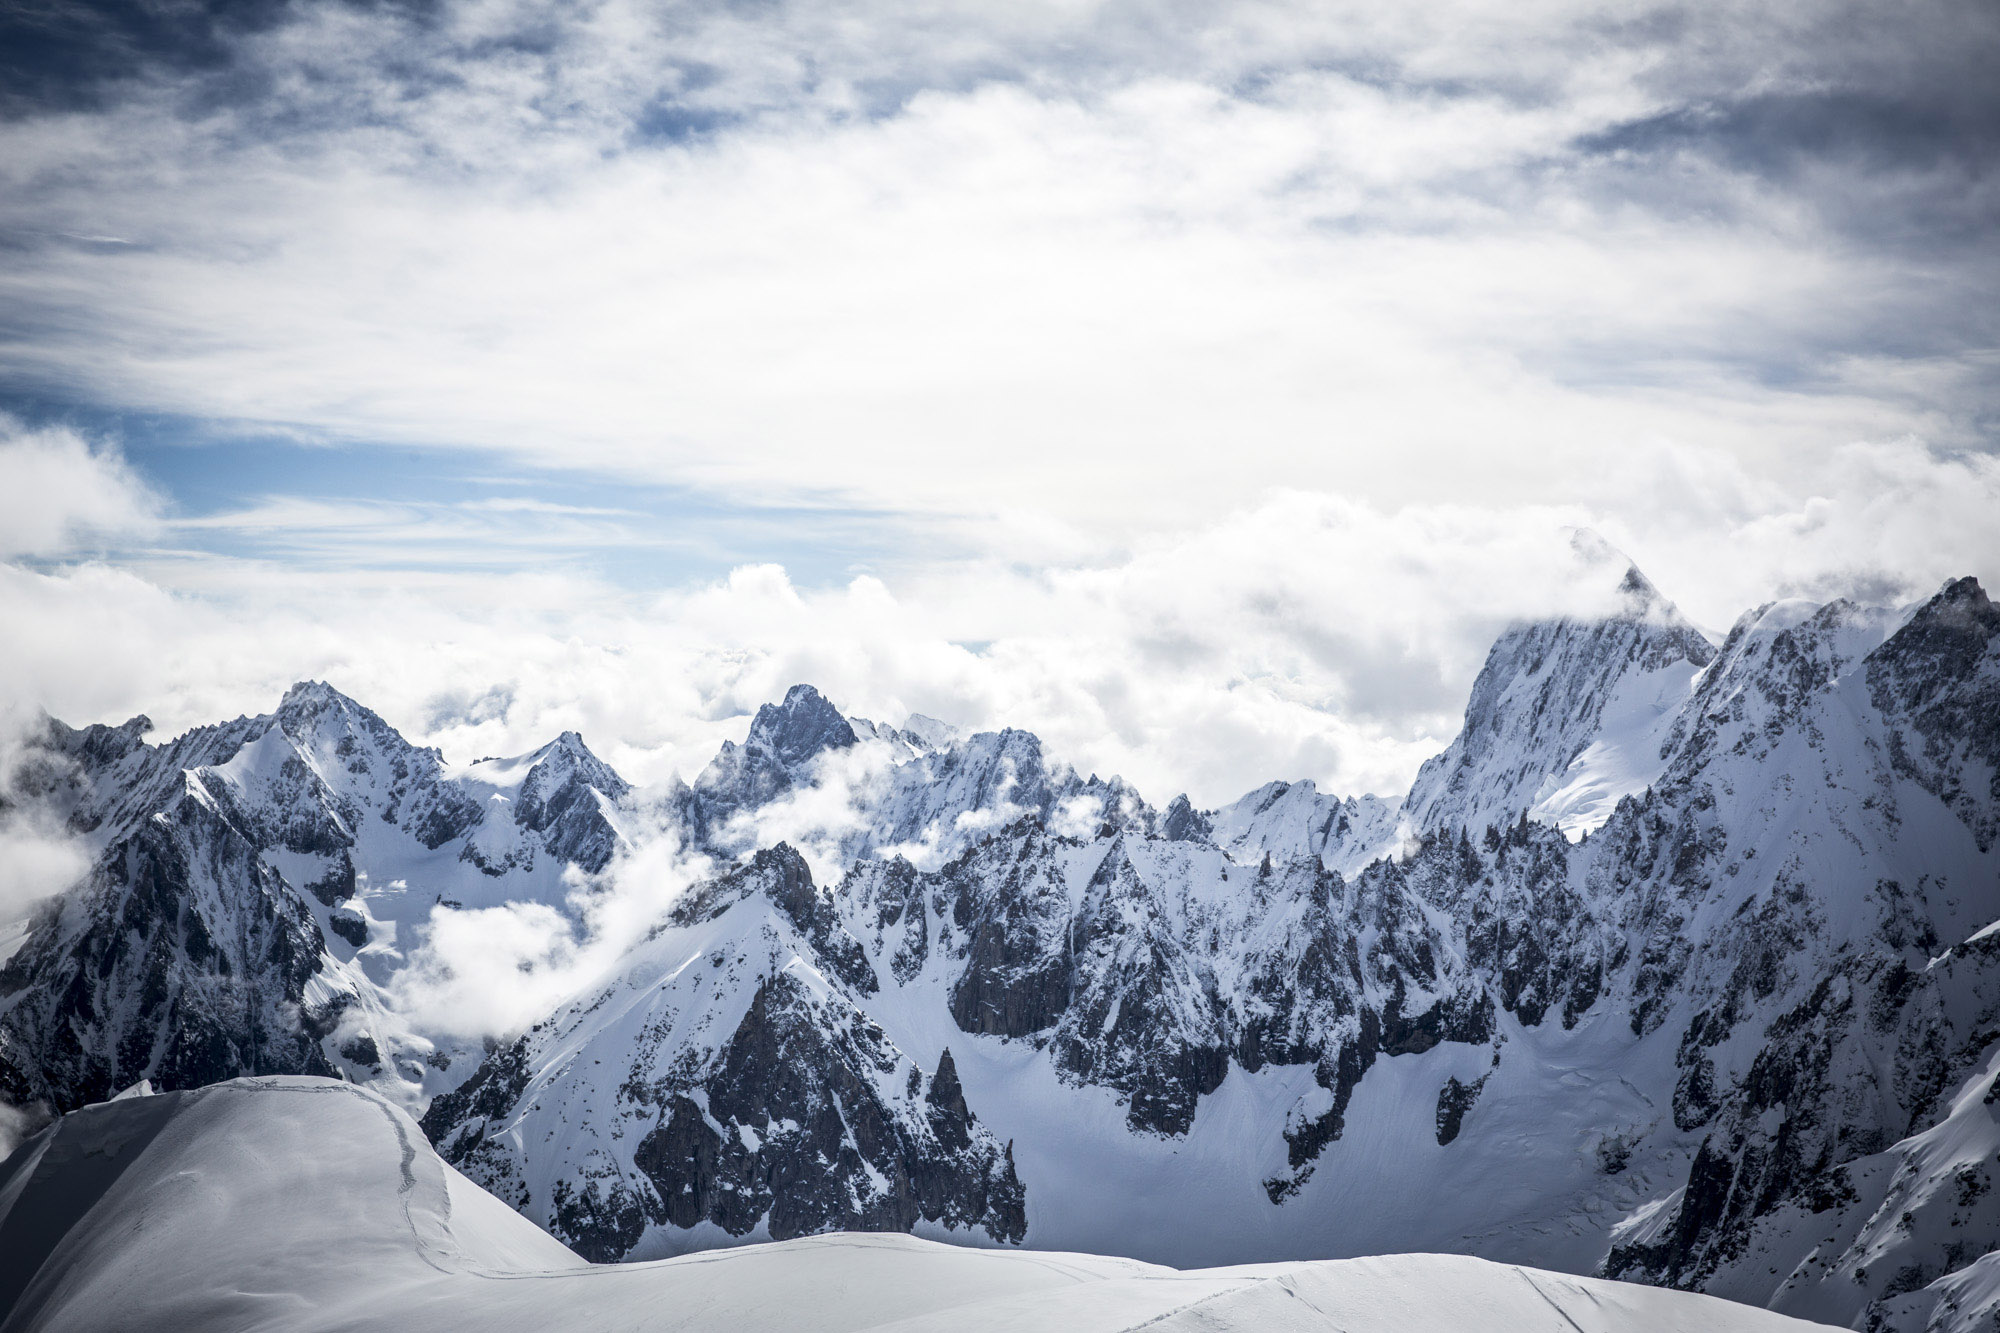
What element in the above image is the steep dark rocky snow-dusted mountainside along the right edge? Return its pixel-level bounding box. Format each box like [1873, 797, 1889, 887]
[1576, 580, 2000, 1327]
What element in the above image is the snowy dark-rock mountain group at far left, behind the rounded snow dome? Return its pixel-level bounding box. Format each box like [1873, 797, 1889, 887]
[0, 683, 630, 1109]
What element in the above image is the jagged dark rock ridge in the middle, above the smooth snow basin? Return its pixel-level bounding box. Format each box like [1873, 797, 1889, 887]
[876, 821, 1504, 1160]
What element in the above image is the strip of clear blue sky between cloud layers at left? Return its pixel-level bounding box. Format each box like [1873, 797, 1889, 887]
[0, 398, 912, 590]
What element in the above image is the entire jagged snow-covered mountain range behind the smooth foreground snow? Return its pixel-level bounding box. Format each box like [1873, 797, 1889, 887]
[0, 548, 2000, 1331]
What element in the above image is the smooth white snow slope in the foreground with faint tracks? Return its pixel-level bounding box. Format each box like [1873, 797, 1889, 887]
[0, 1079, 1818, 1333]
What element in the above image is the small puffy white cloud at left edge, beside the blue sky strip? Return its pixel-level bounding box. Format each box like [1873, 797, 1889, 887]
[0, 414, 160, 556]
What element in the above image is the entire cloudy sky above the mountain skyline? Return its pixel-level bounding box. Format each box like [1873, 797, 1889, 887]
[0, 0, 2000, 803]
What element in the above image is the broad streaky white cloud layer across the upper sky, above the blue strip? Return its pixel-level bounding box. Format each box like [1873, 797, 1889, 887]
[0, 0, 2000, 560]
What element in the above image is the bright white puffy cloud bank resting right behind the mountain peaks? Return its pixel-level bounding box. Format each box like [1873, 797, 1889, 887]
[0, 420, 2000, 805]
